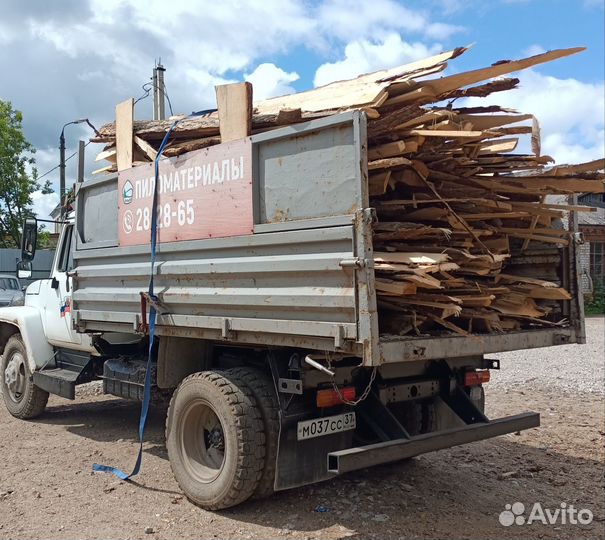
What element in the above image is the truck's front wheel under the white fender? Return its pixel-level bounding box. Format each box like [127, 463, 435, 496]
[0, 334, 48, 420]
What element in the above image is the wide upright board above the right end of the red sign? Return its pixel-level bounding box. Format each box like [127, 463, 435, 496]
[215, 82, 252, 142]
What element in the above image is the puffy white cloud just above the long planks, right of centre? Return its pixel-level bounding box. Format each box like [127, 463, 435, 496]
[314, 32, 441, 86]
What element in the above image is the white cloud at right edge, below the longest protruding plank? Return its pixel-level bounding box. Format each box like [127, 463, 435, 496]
[466, 70, 605, 163]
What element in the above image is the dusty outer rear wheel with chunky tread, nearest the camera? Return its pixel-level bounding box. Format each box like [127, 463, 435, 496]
[166, 371, 265, 510]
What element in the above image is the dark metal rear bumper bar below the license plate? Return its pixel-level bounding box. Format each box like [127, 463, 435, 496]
[328, 412, 540, 474]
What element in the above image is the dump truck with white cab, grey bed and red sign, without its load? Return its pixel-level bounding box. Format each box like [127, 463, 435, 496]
[0, 110, 585, 510]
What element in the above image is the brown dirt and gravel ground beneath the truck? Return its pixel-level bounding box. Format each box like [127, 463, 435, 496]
[0, 318, 605, 539]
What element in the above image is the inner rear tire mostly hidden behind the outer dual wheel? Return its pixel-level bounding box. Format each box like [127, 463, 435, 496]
[228, 367, 280, 499]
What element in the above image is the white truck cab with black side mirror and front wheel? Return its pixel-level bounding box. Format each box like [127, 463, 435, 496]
[0, 219, 99, 418]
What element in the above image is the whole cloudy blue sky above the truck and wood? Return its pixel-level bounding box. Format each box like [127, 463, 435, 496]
[0, 0, 605, 217]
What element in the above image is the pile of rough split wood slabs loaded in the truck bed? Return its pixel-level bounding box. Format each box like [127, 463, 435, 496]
[93, 48, 605, 335]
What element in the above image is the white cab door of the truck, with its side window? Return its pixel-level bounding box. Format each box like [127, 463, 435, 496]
[40, 224, 92, 350]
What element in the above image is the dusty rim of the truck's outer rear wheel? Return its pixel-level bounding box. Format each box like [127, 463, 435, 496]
[179, 399, 225, 484]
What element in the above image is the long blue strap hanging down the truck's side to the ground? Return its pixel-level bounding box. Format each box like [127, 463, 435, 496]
[92, 120, 180, 480]
